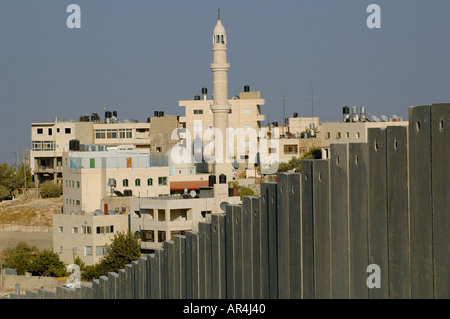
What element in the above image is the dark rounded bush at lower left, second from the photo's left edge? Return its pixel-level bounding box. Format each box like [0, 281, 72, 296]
[28, 250, 66, 277]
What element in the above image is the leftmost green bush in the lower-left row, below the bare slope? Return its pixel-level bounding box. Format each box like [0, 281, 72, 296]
[2, 241, 39, 275]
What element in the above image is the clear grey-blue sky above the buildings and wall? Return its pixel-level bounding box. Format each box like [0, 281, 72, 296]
[0, 0, 450, 162]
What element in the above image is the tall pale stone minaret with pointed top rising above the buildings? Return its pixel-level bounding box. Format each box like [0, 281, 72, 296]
[210, 9, 232, 181]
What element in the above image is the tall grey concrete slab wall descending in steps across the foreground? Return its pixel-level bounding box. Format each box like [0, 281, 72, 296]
[5, 104, 450, 299]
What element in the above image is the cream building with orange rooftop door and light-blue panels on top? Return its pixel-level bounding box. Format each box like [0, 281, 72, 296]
[63, 146, 170, 213]
